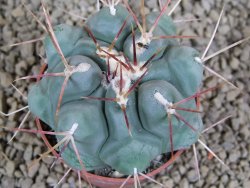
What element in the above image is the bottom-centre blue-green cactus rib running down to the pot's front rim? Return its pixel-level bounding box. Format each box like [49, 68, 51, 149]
[100, 88, 162, 174]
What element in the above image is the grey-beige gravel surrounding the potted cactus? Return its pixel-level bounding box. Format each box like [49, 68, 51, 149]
[0, 0, 250, 188]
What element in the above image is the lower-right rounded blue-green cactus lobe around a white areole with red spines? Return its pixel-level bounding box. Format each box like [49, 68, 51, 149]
[138, 80, 202, 153]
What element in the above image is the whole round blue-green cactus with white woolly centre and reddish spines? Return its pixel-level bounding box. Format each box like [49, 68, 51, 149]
[28, 4, 203, 175]
